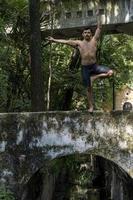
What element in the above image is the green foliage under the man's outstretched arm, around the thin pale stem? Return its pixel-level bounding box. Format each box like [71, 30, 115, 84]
[42, 44, 72, 110]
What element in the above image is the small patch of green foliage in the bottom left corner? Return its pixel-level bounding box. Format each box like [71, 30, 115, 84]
[0, 186, 15, 200]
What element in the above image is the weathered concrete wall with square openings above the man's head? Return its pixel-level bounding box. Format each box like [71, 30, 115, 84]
[42, 0, 133, 37]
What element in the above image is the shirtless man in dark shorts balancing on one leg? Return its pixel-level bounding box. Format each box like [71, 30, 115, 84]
[48, 19, 113, 112]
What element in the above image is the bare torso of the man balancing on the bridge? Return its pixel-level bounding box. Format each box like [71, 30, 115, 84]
[78, 38, 97, 65]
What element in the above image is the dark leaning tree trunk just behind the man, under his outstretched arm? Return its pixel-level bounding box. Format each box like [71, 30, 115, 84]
[62, 49, 80, 110]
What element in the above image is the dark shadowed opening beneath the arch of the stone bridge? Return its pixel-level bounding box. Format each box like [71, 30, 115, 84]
[21, 154, 133, 200]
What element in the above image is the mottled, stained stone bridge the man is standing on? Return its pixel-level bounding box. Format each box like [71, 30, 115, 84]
[0, 111, 133, 198]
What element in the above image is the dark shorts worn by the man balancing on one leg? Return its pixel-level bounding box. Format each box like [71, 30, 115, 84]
[81, 63, 110, 87]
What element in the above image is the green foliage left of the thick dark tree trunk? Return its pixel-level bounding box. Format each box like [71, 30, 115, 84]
[0, 0, 30, 112]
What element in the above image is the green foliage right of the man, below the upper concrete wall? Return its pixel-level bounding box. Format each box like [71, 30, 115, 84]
[100, 34, 133, 88]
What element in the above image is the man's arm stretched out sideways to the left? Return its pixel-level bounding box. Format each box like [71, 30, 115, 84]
[47, 37, 79, 47]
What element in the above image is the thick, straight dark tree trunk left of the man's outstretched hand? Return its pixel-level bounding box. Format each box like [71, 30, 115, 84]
[29, 0, 44, 111]
